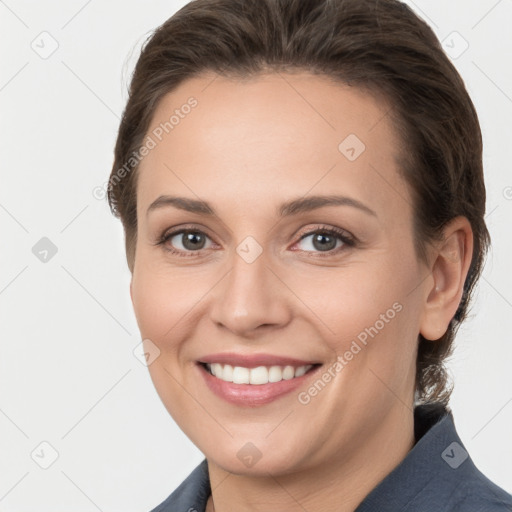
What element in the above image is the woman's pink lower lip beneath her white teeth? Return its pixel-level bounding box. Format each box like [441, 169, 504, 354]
[197, 364, 320, 407]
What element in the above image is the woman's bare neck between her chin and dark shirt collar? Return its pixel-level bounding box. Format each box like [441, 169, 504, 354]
[206, 406, 415, 512]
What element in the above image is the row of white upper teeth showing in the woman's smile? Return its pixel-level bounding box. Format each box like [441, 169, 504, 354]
[206, 363, 313, 385]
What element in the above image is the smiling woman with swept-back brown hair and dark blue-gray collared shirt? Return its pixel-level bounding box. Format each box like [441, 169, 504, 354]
[108, 0, 512, 512]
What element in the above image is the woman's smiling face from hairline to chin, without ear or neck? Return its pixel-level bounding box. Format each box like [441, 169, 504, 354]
[131, 73, 432, 475]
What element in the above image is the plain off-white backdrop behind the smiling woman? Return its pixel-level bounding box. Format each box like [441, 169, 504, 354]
[0, 0, 512, 512]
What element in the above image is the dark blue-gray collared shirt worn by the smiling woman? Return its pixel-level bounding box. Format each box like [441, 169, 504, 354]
[151, 404, 512, 512]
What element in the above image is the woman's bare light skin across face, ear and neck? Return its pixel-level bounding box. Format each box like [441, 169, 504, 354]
[130, 72, 472, 512]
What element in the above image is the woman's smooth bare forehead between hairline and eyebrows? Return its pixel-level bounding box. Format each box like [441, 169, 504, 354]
[137, 73, 407, 222]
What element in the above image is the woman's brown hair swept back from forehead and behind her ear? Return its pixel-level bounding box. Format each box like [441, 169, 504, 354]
[107, 0, 490, 404]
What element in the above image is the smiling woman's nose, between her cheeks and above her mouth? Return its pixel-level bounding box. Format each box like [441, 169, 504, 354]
[210, 246, 293, 338]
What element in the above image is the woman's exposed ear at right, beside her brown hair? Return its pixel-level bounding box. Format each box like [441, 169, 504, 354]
[420, 216, 473, 340]
